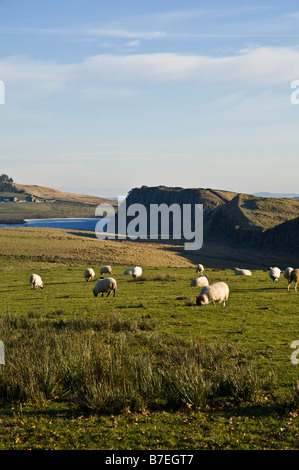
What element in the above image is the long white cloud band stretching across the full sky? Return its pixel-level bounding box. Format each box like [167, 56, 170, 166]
[0, 47, 299, 93]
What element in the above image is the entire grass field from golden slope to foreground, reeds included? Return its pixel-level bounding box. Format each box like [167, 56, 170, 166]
[0, 228, 299, 450]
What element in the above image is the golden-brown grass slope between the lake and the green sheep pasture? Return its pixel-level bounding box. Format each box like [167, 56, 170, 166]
[0, 227, 191, 267]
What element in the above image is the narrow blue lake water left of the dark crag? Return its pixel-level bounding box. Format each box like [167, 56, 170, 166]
[0, 218, 107, 232]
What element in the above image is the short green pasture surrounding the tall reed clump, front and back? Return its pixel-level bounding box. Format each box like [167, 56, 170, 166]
[0, 232, 299, 450]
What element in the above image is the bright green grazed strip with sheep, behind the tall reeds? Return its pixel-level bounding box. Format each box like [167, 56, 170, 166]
[0, 261, 299, 370]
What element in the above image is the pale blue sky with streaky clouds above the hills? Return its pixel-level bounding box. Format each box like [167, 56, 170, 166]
[0, 0, 299, 196]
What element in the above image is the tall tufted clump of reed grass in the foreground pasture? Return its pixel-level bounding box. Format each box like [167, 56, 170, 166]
[0, 314, 275, 414]
